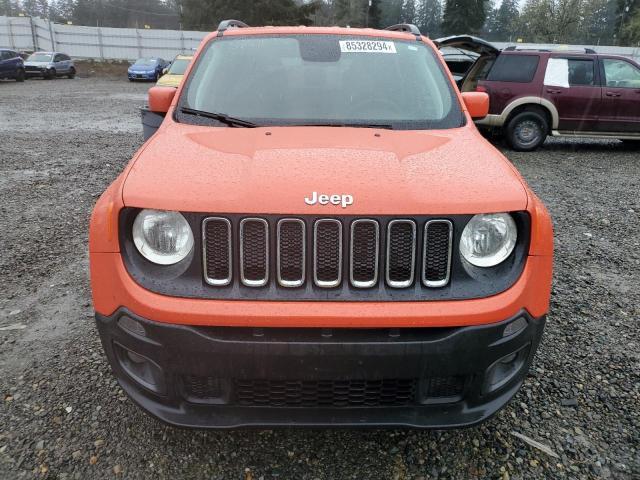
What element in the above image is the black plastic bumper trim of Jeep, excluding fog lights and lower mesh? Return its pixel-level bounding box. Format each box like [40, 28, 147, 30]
[96, 308, 545, 428]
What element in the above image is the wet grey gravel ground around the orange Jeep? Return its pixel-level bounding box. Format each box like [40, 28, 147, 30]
[0, 78, 640, 480]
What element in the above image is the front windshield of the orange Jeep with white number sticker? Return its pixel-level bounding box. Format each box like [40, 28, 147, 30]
[176, 35, 464, 129]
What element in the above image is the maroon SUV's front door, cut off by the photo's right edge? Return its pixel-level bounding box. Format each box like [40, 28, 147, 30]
[599, 57, 640, 134]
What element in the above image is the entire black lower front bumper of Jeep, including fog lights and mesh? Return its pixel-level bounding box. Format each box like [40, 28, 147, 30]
[96, 309, 545, 428]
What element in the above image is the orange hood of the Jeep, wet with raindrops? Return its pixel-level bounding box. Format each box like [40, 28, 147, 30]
[123, 124, 527, 215]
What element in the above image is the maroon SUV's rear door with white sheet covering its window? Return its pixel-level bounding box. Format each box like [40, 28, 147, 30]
[543, 54, 602, 132]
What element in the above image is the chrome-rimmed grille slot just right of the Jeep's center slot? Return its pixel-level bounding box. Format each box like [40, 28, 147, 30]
[349, 220, 380, 288]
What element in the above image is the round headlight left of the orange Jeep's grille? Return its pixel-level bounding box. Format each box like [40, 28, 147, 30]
[133, 210, 193, 265]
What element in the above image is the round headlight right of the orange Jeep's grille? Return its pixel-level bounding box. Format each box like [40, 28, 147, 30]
[460, 213, 518, 267]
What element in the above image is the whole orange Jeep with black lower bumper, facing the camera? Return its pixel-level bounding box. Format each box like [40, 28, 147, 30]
[90, 20, 553, 428]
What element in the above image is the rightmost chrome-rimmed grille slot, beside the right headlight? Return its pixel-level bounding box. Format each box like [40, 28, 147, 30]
[422, 220, 453, 288]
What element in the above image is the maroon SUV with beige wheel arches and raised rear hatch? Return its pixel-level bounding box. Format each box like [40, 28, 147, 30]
[436, 36, 640, 151]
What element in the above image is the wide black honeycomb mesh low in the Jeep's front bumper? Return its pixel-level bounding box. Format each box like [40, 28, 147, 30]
[235, 378, 417, 407]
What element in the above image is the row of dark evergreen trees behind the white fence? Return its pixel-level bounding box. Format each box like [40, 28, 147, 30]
[0, 0, 640, 46]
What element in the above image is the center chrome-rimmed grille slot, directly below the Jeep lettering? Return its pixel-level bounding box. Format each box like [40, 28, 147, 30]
[313, 219, 342, 288]
